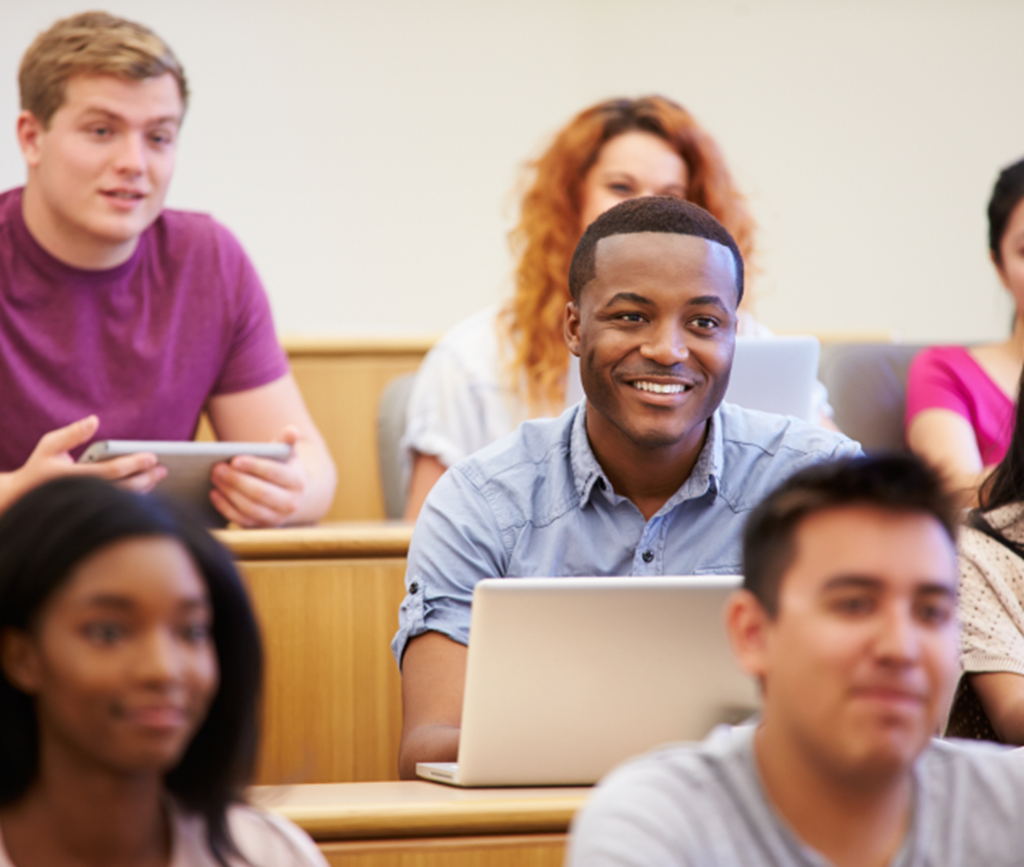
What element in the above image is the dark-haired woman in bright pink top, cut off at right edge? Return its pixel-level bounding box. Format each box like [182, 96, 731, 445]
[905, 160, 1024, 505]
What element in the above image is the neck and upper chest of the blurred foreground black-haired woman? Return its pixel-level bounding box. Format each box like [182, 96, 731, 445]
[0, 744, 170, 867]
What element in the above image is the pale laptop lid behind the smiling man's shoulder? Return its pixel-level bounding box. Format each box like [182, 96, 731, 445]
[725, 335, 821, 422]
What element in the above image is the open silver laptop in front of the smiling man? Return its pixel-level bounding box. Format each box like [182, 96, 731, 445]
[416, 575, 758, 786]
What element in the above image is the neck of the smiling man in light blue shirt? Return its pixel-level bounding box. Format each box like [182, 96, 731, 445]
[587, 403, 710, 520]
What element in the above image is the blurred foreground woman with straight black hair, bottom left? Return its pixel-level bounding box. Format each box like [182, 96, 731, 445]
[0, 477, 326, 867]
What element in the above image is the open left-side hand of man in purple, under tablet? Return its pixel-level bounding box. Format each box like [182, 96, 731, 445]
[0, 416, 167, 511]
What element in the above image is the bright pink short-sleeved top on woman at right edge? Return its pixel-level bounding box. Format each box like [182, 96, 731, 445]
[903, 346, 1016, 467]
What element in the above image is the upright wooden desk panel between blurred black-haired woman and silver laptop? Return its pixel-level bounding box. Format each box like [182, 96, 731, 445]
[239, 558, 406, 783]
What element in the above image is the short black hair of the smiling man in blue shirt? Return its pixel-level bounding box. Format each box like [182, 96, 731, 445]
[569, 196, 743, 304]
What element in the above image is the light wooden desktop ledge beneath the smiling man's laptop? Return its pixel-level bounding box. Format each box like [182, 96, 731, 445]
[250, 781, 590, 840]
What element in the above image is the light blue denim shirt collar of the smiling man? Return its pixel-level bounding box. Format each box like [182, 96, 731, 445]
[569, 398, 724, 515]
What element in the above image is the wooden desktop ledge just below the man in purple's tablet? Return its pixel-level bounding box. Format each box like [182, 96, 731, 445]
[213, 521, 413, 560]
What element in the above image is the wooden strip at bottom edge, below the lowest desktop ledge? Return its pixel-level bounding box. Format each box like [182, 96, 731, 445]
[321, 834, 565, 867]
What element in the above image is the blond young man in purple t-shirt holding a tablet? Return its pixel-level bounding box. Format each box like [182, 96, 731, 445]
[0, 12, 335, 526]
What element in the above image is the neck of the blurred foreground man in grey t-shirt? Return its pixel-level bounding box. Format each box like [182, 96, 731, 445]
[754, 723, 913, 867]
